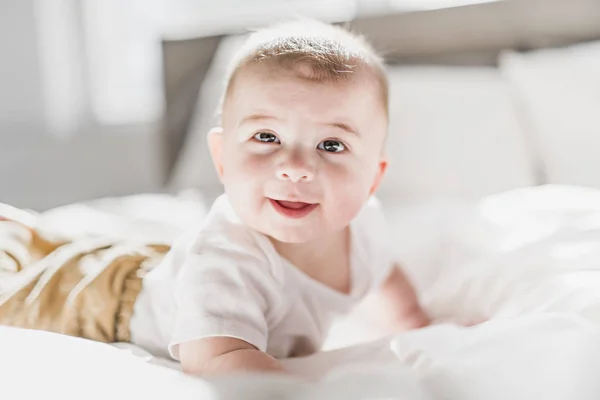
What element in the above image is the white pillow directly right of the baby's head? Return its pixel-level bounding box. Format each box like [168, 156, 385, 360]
[380, 66, 536, 204]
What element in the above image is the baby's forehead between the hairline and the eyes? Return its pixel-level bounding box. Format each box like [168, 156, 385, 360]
[222, 63, 387, 140]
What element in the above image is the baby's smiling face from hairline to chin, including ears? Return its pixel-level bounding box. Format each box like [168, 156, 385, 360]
[209, 65, 387, 243]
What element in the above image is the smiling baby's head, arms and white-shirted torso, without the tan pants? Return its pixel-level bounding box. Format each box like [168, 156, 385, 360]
[130, 22, 428, 374]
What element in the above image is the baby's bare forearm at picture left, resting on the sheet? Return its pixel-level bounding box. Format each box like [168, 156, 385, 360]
[179, 337, 285, 376]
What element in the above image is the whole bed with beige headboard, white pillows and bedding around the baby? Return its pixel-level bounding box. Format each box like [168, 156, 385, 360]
[0, 0, 600, 400]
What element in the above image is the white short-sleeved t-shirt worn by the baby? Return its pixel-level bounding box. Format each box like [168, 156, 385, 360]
[130, 195, 394, 360]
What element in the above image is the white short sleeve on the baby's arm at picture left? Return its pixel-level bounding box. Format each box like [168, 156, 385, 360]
[169, 249, 280, 360]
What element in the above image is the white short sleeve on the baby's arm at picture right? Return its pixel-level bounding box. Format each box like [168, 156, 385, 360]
[353, 197, 396, 291]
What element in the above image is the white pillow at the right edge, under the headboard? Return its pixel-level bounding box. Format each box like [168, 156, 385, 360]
[500, 41, 600, 188]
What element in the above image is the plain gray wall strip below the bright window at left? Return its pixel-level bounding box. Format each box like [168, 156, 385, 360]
[0, 126, 163, 211]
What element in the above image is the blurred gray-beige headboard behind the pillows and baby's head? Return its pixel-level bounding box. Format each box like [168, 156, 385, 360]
[158, 0, 600, 180]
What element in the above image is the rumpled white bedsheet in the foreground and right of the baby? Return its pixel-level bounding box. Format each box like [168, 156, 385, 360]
[0, 186, 600, 400]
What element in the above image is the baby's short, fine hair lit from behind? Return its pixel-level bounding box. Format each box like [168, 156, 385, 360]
[219, 20, 388, 114]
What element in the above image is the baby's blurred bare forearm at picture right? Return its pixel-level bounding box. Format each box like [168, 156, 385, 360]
[380, 264, 430, 330]
